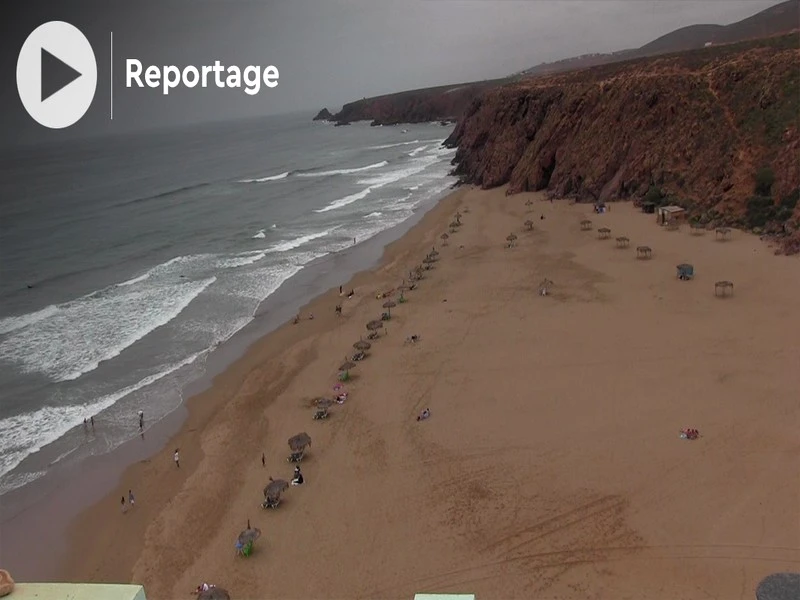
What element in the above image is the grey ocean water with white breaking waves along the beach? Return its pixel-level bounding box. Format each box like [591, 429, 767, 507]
[0, 115, 454, 494]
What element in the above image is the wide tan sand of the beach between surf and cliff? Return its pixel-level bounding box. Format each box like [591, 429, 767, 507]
[59, 188, 800, 600]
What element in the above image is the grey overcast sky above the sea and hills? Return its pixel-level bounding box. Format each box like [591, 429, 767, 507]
[0, 0, 788, 143]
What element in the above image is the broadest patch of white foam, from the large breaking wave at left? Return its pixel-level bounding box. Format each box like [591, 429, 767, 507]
[0, 276, 216, 381]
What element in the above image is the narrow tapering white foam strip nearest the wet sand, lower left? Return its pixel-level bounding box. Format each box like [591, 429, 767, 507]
[0, 351, 206, 482]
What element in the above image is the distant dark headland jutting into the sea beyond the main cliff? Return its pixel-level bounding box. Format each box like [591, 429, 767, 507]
[333, 80, 508, 125]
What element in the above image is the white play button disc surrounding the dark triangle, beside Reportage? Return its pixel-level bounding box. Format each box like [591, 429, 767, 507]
[17, 21, 97, 129]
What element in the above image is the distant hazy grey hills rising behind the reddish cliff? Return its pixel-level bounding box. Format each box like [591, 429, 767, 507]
[522, 0, 800, 76]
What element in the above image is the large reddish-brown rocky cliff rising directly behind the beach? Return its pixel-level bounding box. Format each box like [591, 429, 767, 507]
[445, 36, 800, 250]
